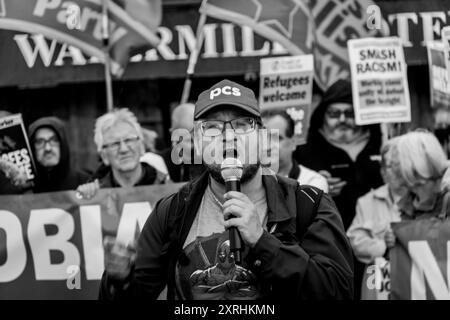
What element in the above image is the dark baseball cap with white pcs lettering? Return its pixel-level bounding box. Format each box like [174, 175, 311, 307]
[194, 80, 261, 120]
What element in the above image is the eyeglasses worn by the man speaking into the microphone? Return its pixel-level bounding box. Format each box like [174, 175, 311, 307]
[200, 117, 256, 137]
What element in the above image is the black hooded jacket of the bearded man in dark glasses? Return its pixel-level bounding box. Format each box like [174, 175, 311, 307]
[294, 81, 383, 230]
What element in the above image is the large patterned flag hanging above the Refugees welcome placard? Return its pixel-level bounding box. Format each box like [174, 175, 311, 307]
[200, 0, 385, 90]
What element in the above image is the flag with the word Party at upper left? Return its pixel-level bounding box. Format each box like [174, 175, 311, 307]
[0, 0, 162, 76]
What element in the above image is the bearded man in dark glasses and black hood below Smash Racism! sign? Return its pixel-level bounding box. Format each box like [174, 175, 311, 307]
[294, 80, 383, 298]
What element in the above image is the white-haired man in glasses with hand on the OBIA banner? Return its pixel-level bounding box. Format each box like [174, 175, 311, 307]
[77, 108, 165, 198]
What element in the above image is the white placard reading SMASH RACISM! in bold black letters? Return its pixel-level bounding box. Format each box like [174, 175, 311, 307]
[347, 37, 411, 125]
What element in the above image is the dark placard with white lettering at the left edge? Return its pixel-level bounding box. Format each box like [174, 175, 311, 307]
[0, 114, 36, 185]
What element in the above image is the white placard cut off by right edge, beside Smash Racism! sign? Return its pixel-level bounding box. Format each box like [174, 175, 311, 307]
[427, 41, 450, 108]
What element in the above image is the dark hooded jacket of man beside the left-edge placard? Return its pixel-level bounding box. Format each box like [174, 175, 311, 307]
[28, 117, 89, 193]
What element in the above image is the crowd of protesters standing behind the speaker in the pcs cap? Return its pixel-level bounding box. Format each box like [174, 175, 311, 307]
[0, 80, 450, 299]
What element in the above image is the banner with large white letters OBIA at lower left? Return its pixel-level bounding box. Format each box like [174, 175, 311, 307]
[0, 184, 182, 299]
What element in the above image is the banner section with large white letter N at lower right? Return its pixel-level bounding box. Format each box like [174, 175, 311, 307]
[390, 218, 450, 300]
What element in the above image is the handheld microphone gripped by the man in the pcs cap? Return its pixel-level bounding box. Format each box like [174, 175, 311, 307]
[220, 158, 244, 264]
